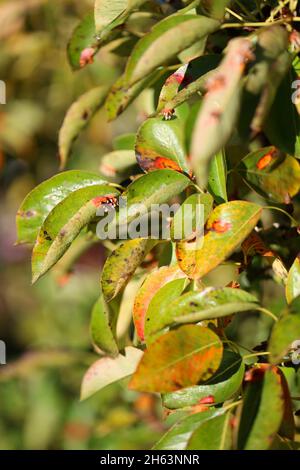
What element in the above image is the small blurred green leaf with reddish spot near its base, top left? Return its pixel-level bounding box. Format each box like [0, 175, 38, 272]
[67, 12, 96, 70]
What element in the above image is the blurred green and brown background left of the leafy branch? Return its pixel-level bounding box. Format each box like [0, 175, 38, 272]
[0, 0, 163, 449]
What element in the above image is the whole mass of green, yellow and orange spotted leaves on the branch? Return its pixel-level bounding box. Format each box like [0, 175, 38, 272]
[9, 0, 300, 450]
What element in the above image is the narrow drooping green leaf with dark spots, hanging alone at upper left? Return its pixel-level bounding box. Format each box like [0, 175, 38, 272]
[58, 86, 107, 168]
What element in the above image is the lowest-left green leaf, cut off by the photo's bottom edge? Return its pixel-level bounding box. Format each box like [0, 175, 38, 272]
[153, 409, 224, 450]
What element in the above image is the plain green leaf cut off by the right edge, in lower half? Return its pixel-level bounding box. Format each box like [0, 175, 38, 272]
[269, 313, 300, 364]
